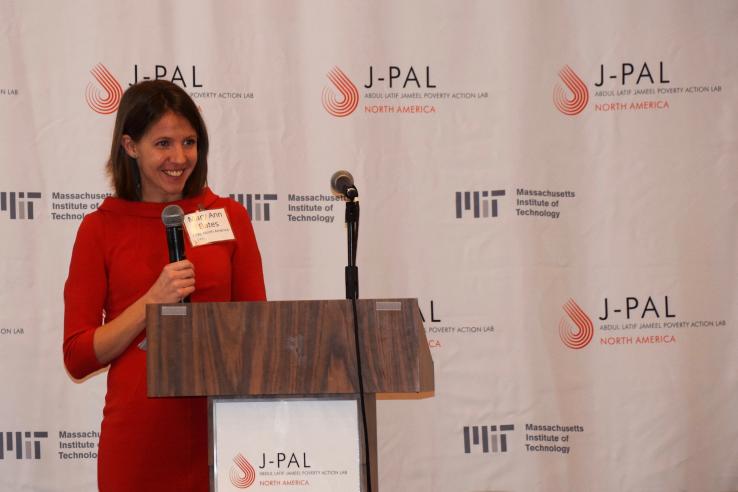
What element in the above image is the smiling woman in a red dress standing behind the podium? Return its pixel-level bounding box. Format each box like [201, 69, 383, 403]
[64, 81, 265, 492]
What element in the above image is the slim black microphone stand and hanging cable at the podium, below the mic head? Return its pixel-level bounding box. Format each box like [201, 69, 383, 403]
[345, 190, 373, 492]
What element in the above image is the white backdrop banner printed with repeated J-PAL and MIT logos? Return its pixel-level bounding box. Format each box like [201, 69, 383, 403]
[0, 0, 738, 492]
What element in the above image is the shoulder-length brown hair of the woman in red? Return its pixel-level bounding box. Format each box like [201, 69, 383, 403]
[106, 80, 209, 201]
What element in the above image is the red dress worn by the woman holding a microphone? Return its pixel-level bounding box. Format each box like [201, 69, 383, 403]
[64, 188, 266, 492]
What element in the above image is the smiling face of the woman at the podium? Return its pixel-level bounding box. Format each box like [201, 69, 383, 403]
[122, 111, 197, 203]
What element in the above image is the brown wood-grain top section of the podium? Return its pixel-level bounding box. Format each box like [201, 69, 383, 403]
[146, 299, 434, 397]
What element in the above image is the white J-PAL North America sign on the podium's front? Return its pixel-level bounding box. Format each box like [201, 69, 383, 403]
[211, 398, 361, 492]
